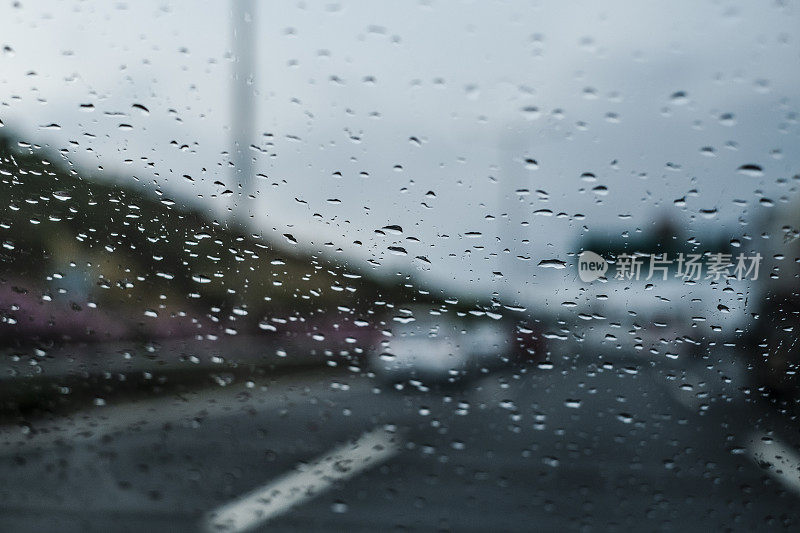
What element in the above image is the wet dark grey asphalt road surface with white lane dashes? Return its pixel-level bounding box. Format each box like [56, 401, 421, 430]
[0, 352, 800, 532]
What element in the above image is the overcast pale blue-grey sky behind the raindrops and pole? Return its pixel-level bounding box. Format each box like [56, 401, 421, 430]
[0, 0, 800, 301]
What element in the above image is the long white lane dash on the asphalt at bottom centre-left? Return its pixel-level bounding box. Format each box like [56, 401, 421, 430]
[205, 429, 400, 533]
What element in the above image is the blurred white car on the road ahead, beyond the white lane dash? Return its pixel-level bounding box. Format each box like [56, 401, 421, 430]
[369, 306, 536, 384]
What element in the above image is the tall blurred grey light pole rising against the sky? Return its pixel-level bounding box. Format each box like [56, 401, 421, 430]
[231, 0, 256, 222]
